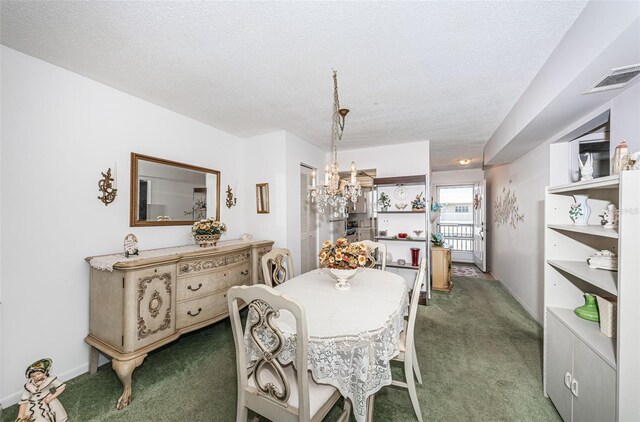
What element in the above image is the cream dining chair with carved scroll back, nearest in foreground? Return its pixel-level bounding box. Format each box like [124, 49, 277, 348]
[227, 284, 351, 422]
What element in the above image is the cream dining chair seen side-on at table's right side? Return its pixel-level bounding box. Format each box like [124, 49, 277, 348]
[391, 257, 427, 422]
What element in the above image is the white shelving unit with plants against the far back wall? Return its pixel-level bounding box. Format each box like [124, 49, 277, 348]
[373, 175, 431, 298]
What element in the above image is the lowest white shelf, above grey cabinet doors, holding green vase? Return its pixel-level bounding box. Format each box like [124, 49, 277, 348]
[547, 307, 616, 370]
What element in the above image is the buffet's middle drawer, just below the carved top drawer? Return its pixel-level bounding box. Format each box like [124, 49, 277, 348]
[176, 262, 250, 302]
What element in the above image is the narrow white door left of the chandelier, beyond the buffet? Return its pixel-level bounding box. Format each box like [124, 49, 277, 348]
[300, 166, 318, 274]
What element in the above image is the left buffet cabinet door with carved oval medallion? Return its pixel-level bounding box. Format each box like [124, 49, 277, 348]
[123, 265, 176, 348]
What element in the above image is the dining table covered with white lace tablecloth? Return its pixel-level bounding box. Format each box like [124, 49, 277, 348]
[245, 267, 409, 422]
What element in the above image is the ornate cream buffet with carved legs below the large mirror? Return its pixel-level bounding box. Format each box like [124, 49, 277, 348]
[85, 240, 273, 409]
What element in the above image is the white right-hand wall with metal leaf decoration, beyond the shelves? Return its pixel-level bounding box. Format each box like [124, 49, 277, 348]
[484, 143, 549, 323]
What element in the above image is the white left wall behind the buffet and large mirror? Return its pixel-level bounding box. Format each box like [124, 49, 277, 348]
[0, 46, 250, 406]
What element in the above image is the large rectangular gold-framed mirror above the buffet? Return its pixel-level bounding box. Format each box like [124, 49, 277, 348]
[129, 152, 220, 227]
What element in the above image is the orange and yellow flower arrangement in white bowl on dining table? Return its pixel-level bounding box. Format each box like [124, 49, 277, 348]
[318, 237, 372, 290]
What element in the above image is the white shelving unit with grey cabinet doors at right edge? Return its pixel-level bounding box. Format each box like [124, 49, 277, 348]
[544, 171, 640, 422]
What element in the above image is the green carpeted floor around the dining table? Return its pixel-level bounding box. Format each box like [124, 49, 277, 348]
[2, 277, 560, 422]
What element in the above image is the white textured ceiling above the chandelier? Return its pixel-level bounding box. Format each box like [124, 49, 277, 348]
[1, 1, 586, 170]
